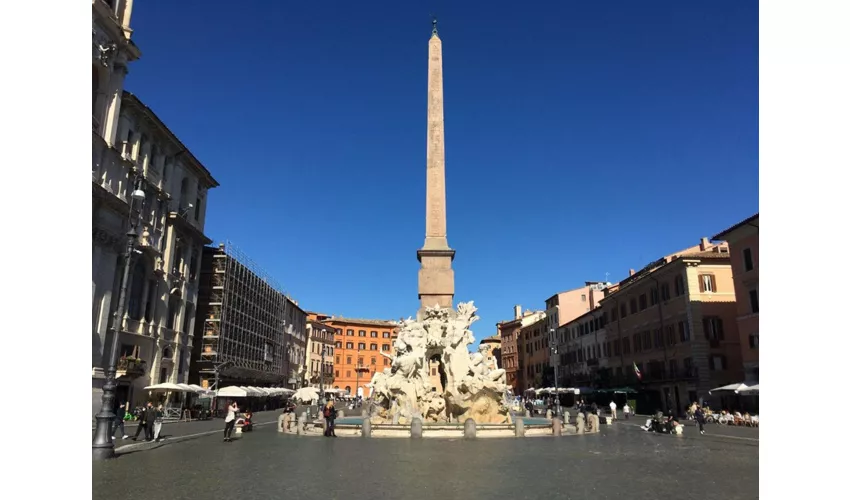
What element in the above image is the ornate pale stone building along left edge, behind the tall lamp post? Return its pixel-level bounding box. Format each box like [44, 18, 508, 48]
[92, 0, 218, 412]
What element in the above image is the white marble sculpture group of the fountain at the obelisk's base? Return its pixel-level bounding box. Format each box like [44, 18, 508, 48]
[369, 302, 510, 424]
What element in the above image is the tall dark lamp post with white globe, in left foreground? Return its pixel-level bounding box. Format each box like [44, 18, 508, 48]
[92, 181, 146, 460]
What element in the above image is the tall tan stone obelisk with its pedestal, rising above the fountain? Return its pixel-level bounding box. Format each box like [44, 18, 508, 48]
[416, 19, 455, 311]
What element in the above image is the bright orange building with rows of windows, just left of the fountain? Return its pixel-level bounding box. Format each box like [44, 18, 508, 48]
[307, 312, 398, 398]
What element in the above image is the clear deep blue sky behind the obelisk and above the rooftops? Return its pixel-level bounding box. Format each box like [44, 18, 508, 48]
[126, 0, 758, 339]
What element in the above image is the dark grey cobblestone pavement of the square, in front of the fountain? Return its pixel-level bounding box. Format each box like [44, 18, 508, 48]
[92, 416, 759, 500]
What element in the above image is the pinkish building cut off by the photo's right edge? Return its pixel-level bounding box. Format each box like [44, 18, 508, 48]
[713, 214, 759, 383]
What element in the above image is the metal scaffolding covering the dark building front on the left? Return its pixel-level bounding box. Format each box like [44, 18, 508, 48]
[198, 241, 286, 386]
